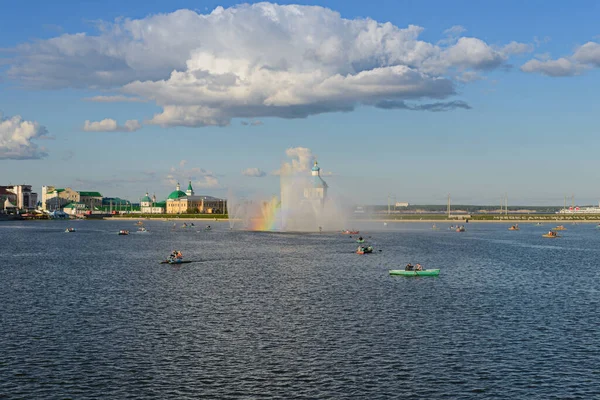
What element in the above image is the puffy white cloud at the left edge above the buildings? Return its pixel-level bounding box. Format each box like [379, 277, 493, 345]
[0, 114, 50, 160]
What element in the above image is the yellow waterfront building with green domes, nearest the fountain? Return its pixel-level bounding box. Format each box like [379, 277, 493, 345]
[166, 181, 227, 214]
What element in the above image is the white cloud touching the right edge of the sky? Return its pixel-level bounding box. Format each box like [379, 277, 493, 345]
[521, 42, 600, 77]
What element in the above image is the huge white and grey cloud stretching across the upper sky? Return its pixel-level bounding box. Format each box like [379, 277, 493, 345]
[3, 3, 524, 126]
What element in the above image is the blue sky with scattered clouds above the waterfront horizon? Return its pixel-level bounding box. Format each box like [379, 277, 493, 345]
[0, 0, 600, 205]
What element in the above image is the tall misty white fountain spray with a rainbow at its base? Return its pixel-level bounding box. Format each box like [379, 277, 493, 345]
[227, 151, 347, 232]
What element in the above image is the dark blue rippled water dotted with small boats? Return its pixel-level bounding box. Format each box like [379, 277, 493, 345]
[0, 221, 600, 399]
